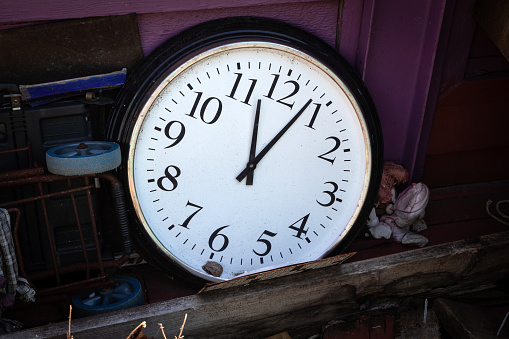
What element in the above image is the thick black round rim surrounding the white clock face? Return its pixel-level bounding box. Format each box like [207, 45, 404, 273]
[106, 17, 383, 284]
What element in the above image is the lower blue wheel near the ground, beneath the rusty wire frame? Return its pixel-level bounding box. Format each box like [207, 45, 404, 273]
[72, 276, 143, 317]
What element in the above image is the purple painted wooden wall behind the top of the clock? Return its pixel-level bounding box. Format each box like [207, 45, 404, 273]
[0, 0, 446, 180]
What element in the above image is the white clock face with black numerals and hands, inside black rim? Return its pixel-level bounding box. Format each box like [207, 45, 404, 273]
[128, 42, 369, 281]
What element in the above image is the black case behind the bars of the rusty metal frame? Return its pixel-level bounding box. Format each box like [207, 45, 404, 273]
[0, 91, 104, 272]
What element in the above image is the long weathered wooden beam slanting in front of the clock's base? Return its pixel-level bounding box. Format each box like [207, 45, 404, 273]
[3, 232, 509, 339]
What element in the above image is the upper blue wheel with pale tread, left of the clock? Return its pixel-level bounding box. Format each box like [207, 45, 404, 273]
[46, 141, 121, 176]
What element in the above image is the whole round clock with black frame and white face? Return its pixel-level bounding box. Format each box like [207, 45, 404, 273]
[108, 17, 383, 281]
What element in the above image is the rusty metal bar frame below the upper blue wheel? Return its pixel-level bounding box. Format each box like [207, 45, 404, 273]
[0, 173, 131, 292]
